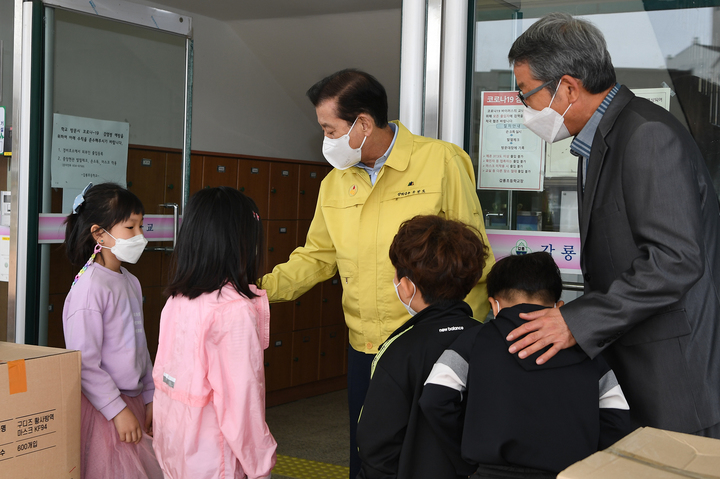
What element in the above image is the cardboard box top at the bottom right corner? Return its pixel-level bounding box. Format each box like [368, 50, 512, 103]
[558, 427, 720, 479]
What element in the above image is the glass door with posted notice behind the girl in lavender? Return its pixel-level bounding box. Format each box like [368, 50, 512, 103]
[9, 0, 192, 353]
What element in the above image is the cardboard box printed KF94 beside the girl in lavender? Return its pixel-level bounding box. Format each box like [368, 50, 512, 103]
[0, 342, 80, 479]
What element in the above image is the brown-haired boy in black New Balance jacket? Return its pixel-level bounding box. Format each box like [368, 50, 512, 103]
[357, 216, 488, 479]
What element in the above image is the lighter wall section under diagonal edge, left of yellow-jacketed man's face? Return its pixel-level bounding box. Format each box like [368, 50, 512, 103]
[192, 10, 322, 161]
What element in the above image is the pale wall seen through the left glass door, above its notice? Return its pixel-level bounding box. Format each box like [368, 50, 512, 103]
[53, 10, 185, 148]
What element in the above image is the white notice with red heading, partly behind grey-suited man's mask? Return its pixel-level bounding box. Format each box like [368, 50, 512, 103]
[478, 91, 545, 191]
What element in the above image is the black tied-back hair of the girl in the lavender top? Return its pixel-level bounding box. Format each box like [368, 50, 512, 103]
[65, 183, 145, 267]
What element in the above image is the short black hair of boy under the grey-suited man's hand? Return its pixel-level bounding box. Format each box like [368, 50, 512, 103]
[487, 251, 562, 303]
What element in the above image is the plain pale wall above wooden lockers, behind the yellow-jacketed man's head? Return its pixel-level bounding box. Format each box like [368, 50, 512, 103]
[146, 2, 400, 162]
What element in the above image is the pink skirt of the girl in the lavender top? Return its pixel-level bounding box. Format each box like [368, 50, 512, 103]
[80, 394, 163, 479]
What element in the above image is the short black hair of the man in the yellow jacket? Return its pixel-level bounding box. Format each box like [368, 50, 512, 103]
[307, 68, 387, 128]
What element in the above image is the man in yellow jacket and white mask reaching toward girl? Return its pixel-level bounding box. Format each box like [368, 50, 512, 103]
[262, 70, 495, 479]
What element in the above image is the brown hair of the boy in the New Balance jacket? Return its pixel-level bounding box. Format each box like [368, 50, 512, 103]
[390, 215, 488, 304]
